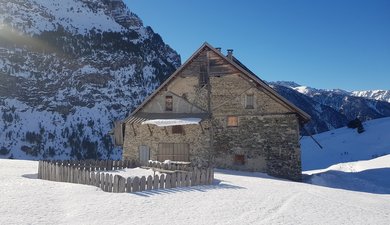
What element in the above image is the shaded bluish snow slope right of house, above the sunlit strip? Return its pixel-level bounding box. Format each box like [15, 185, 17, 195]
[301, 117, 390, 170]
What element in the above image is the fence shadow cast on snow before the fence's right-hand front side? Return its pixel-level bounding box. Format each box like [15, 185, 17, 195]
[128, 180, 245, 197]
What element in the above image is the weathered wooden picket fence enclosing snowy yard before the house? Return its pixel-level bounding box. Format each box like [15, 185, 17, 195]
[38, 161, 214, 193]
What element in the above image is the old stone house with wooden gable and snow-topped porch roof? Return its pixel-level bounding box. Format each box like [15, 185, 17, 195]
[115, 43, 310, 180]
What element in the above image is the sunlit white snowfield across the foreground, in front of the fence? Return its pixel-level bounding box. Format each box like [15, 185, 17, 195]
[0, 156, 390, 225]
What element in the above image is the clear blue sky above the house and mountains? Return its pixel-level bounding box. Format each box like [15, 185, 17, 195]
[125, 0, 390, 90]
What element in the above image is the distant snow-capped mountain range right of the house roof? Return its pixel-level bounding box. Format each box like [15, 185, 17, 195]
[269, 81, 390, 135]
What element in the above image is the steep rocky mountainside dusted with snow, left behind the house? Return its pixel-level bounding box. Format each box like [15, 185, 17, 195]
[0, 0, 181, 159]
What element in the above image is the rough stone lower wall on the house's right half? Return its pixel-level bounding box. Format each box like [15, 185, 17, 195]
[214, 114, 301, 180]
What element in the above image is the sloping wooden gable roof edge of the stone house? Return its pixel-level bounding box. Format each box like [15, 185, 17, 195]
[124, 42, 310, 123]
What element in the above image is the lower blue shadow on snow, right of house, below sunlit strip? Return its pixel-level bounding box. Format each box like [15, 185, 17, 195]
[304, 168, 390, 194]
